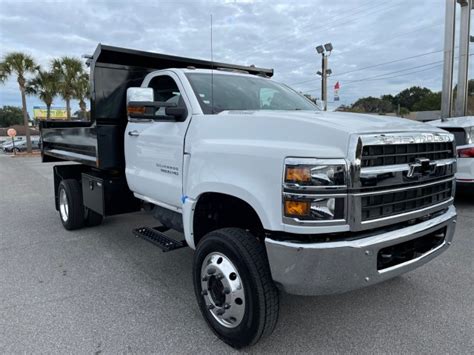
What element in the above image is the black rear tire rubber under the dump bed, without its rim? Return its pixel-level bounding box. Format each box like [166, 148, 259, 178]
[58, 179, 84, 230]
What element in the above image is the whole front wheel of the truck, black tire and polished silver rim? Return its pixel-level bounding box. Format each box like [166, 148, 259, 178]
[193, 228, 279, 348]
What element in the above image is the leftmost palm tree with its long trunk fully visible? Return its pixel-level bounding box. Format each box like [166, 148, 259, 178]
[0, 52, 38, 153]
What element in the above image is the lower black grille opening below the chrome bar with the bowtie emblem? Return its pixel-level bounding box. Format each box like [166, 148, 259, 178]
[361, 181, 453, 221]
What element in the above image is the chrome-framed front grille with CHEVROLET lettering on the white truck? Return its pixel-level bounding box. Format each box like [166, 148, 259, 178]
[347, 132, 456, 231]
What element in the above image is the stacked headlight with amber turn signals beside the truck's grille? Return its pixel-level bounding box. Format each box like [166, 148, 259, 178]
[283, 158, 347, 223]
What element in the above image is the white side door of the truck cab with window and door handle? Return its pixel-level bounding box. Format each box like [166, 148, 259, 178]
[125, 72, 191, 208]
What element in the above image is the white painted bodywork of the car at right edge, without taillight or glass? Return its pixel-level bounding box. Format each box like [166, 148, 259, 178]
[428, 116, 474, 185]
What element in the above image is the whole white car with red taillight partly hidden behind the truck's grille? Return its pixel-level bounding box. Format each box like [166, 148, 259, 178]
[428, 116, 474, 187]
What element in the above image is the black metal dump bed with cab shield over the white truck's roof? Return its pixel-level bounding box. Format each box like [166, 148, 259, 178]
[40, 44, 273, 171]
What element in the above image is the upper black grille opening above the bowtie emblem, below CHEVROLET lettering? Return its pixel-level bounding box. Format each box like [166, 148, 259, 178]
[361, 142, 454, 167]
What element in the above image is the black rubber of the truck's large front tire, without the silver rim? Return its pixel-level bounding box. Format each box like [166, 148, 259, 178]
[193, 228, 279, 348]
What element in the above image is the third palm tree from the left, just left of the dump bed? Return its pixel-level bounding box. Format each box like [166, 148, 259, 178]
[53, 57, 84, 119]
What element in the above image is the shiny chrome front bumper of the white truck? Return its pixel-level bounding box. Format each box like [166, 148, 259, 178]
[265, 206, 456, 296]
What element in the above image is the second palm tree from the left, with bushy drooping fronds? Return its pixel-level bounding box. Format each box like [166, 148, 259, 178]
[26, 69, 59, 119]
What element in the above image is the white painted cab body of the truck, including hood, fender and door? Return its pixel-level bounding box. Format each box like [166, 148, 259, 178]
[125, 69, 450, 248]
